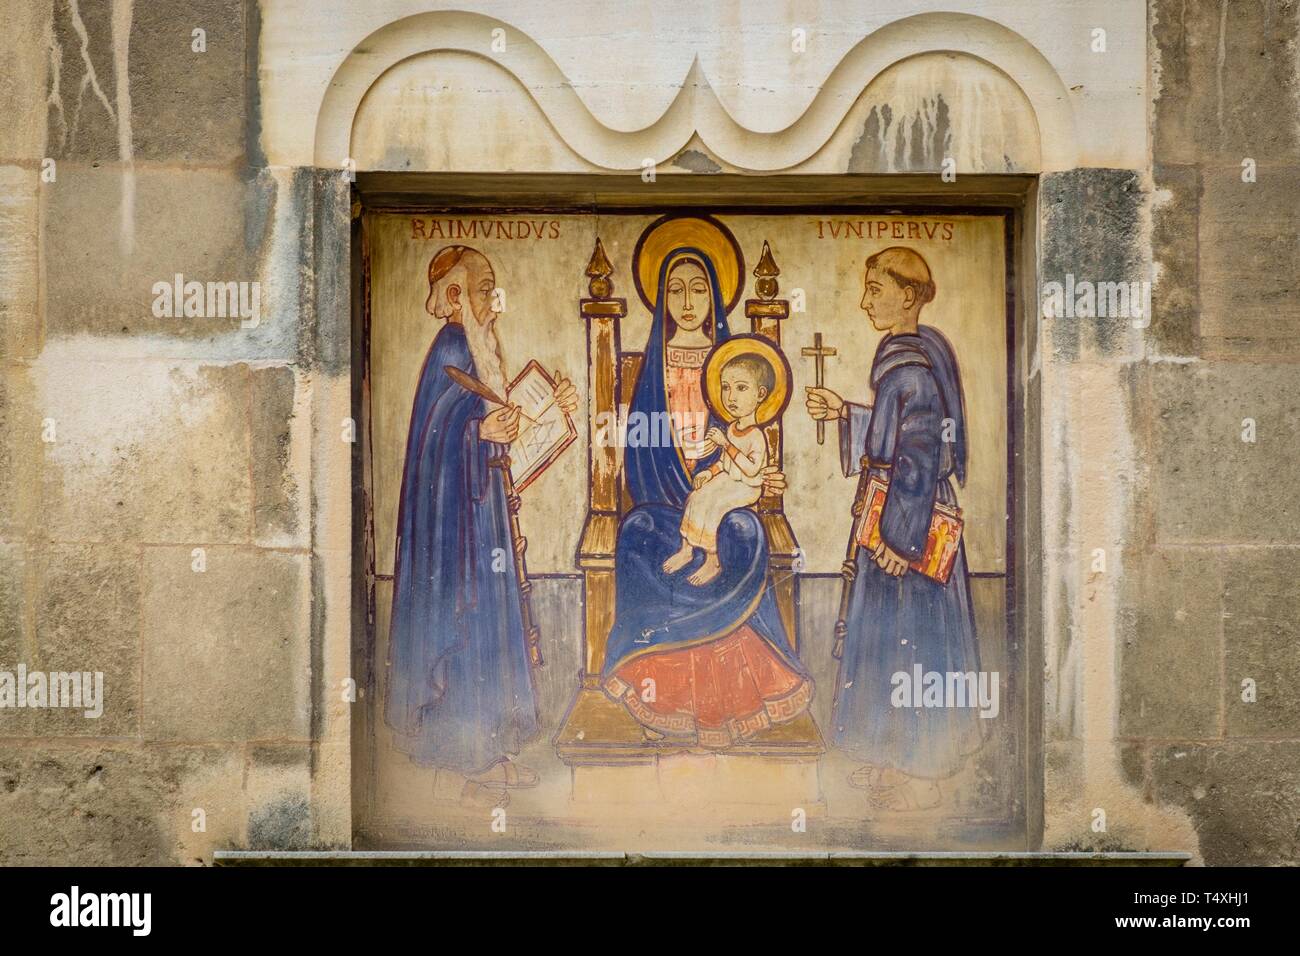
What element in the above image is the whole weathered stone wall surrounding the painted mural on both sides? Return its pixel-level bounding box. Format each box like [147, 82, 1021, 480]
[0, 0, 1300, 864]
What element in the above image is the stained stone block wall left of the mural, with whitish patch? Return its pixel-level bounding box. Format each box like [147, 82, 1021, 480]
[0, 0, 350, 864]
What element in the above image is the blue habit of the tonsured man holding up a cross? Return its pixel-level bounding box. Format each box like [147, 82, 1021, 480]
[832, 325, 984, 778]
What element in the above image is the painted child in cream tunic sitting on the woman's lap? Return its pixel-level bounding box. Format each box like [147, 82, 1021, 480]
[663, 352, 776, 587]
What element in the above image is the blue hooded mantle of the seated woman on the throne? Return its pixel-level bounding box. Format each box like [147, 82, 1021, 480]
[605, 247, 806, 675]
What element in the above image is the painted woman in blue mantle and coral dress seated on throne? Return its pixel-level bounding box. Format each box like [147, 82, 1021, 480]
[602, 230, 813, 749]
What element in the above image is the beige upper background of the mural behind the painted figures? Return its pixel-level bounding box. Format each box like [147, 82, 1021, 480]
[369, 213, 1006, 574]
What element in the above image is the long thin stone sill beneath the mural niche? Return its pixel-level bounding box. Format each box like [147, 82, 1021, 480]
[212, 849, 1192, 866]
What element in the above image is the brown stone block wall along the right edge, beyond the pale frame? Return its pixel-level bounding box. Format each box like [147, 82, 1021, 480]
[1117, 0, 1300, 864]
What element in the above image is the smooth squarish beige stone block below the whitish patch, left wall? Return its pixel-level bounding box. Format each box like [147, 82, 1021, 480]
[143, 548, 311, 741]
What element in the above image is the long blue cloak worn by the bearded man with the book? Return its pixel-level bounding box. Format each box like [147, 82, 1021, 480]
[385, 323, 538, 774]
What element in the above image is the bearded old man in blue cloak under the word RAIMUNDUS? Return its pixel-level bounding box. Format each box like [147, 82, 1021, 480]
[385, 246, 577, 806]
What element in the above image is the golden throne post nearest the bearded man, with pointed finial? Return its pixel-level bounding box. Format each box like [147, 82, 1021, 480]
[577, 237, 628, 688]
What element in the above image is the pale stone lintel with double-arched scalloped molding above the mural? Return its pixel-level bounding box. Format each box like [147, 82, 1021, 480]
[261, 0, 1147, 172]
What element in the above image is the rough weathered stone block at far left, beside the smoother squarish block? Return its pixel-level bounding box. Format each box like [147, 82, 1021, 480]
[27, 545, 140, 737]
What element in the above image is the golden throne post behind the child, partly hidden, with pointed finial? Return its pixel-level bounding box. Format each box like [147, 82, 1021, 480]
[745, 239, 803, 650]
